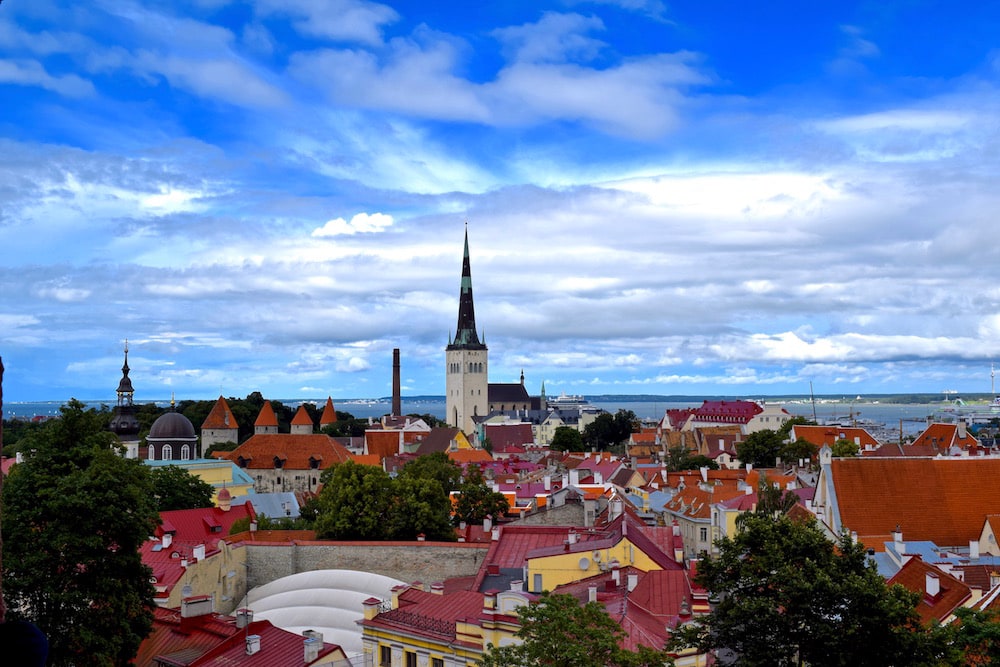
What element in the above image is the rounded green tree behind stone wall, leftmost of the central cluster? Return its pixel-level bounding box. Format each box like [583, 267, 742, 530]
[315, 461, 393, 540]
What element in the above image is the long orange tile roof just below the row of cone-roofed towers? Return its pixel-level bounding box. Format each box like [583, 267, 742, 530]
[220, 433, 351, 470]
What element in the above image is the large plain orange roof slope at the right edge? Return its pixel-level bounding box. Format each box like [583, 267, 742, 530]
[830, 457, 1000, 546]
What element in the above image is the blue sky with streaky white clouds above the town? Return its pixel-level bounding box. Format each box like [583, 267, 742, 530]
[0, 0, 1000, 401]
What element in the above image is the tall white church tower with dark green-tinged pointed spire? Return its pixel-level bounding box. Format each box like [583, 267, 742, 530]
[445, 226, 489, 433]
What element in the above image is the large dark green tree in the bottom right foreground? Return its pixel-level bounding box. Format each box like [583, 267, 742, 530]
[669, 513, 941, 667]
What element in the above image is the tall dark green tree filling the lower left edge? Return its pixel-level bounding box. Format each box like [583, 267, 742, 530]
[3, 400, 159, 667]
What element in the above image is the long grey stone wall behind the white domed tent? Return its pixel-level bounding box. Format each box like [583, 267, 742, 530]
[246, 542, 490, 588]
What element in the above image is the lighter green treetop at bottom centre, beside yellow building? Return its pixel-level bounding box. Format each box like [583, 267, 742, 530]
[480, 592, 673, 667]
